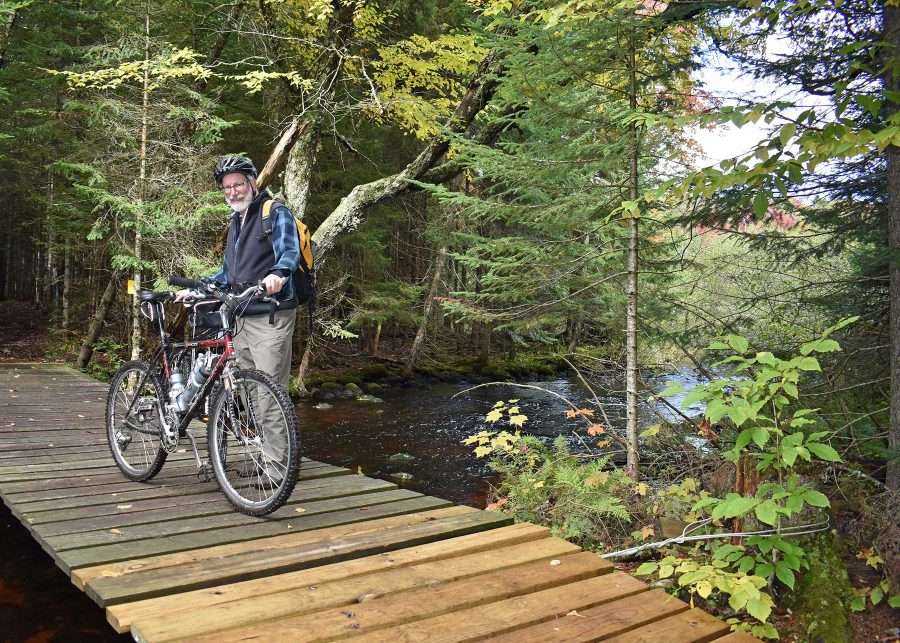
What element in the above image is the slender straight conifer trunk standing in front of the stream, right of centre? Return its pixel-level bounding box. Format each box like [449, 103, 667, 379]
[625, 34, 641, 480]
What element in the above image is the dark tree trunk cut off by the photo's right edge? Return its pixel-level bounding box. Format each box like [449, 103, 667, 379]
[883, 3, 900, 491]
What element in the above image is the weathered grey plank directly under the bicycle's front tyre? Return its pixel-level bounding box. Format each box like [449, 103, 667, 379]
[44, 488, 421, 552]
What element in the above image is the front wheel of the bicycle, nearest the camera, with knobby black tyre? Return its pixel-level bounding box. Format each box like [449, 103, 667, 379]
[207, 370, 300, 516]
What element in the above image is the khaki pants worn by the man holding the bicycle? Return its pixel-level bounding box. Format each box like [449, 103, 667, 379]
[234, 308, 297, 478]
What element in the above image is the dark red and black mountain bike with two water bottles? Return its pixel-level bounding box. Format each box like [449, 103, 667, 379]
[106, 276, 300, 516]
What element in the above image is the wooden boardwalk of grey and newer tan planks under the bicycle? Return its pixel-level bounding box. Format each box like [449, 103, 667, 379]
[0, 364, 756, 643]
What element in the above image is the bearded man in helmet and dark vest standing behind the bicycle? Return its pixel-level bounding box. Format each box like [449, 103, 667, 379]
[176, 156, 300, 484]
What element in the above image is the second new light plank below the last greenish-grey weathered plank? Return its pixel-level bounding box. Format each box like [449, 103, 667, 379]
[131, 538, 581, 642]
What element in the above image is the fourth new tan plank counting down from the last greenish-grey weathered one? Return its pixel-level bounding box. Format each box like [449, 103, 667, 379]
[334, 572, 652, 643]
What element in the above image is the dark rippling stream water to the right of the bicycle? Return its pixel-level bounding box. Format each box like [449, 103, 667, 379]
[297, 370, 699, 507]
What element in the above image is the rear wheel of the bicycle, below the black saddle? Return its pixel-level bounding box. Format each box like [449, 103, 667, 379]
[106, 361, 168, 482]
